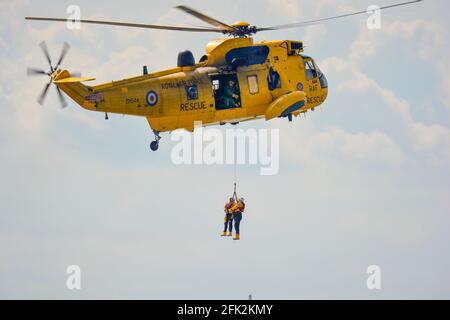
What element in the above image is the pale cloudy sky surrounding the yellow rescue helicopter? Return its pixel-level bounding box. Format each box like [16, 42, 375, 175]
[0, 0, 450, 299]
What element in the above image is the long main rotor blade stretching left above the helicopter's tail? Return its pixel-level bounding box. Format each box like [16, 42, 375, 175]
[25, 17, 223, 33]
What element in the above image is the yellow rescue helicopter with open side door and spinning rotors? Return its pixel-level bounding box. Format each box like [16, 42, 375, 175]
[25, 0, 421, 151]
